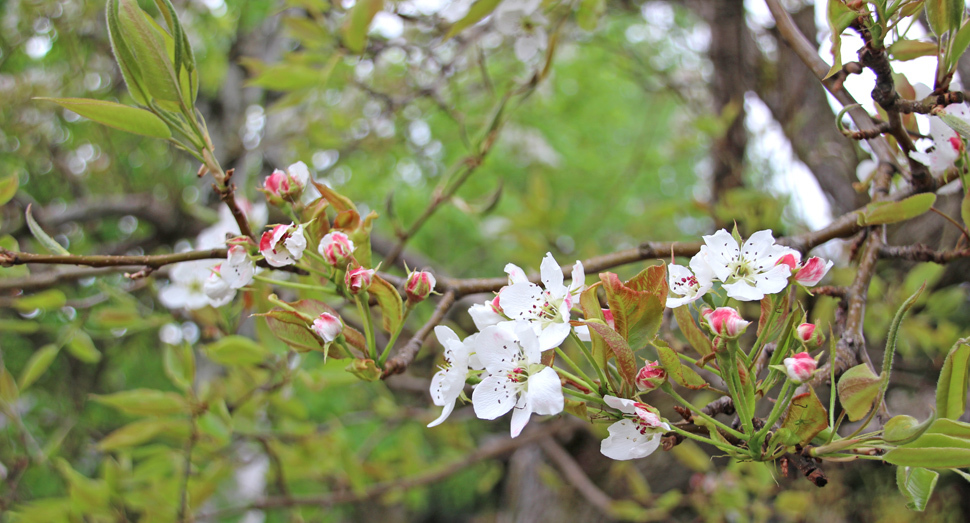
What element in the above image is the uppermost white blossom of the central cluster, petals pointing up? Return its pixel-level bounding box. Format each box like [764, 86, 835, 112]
[499, 253, 586, 351]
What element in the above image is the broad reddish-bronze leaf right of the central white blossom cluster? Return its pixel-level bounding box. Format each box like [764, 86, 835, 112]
[600, 265, 668, 349]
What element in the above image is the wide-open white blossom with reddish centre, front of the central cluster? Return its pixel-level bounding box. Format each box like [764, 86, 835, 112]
[472, 321, 565, 438]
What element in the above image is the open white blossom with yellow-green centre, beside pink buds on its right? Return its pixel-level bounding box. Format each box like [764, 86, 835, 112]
[704, 229, 797, 301]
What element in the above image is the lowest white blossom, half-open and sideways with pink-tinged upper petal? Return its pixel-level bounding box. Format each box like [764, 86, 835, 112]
[600, 395, 670, 460]
